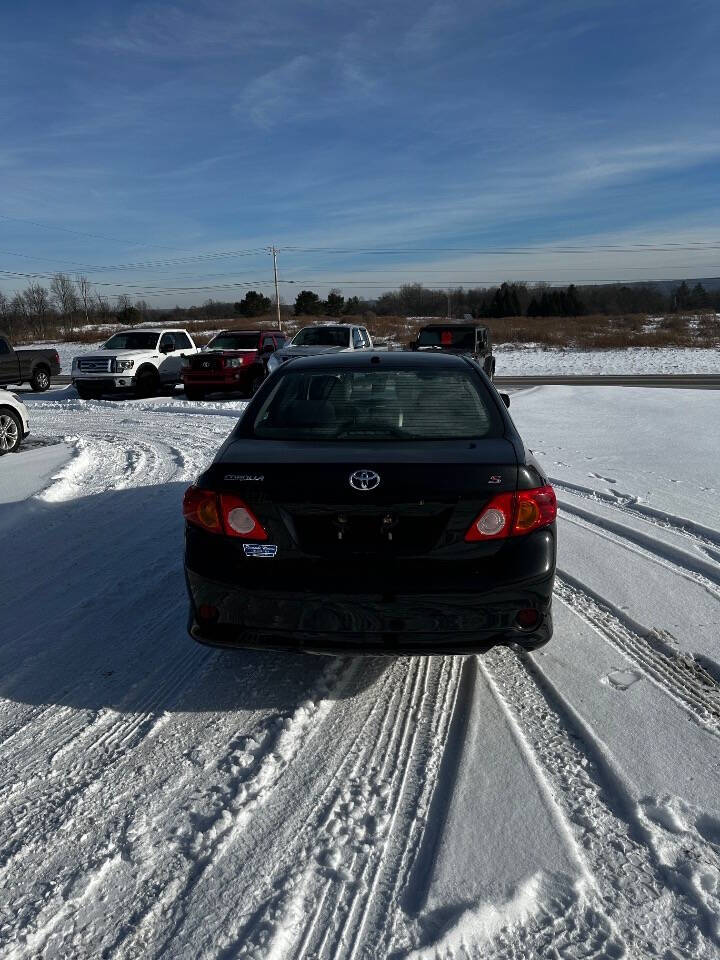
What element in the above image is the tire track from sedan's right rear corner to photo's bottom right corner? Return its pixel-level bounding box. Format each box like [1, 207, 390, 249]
[480, 648, 720, 960]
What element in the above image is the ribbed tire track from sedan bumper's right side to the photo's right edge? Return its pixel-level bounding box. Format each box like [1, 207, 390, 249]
[555, 571, 720, 736]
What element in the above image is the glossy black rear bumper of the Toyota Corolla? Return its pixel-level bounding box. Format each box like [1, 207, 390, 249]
[186, 561, 554, 655]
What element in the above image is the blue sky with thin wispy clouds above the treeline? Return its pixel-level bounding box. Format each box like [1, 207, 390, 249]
[0, 0, 720, 305]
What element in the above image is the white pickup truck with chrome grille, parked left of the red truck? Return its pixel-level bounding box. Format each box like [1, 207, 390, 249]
[72, 327, 199, 400]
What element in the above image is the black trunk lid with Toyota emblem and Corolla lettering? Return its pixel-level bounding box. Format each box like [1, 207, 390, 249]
[205, 438, 517, 557]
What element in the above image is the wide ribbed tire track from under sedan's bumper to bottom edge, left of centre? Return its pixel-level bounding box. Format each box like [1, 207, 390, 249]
[208, 657, 461, 960]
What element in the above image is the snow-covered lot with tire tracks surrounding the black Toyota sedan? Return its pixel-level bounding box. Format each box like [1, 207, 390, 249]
[0, 387, 720, 960]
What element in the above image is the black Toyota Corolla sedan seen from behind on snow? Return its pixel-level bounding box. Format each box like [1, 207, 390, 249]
[183, 352, 556, 654]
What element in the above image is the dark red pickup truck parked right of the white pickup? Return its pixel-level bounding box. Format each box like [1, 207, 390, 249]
[182, 330, 288, 400]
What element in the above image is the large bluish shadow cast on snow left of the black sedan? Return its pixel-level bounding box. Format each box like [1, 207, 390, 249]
[0, 483, 388, 713]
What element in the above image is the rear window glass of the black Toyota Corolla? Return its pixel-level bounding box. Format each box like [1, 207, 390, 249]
[252, 370, 502, 440]
